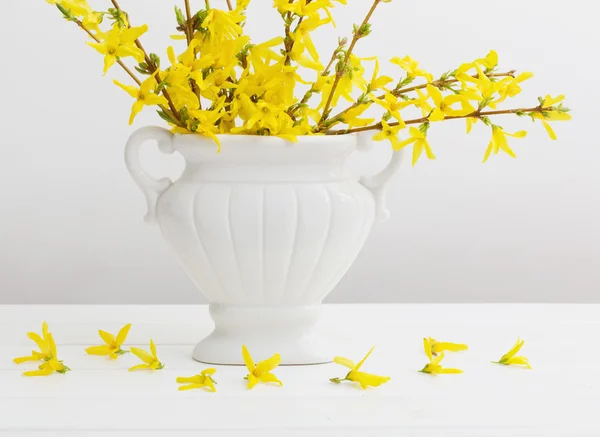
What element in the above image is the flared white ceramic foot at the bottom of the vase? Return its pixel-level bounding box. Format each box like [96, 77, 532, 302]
[192, 304, 333, 366]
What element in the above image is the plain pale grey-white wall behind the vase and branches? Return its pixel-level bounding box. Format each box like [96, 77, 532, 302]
[0, 0, 600, 303]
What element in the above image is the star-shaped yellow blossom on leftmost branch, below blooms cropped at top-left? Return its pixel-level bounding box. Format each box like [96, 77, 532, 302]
[88, 24, 148, 74]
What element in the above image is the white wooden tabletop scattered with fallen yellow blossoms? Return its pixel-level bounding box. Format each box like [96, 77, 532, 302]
[0, 304, 600, 437]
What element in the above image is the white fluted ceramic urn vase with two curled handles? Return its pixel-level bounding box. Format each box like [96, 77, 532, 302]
[125, 127, 402, 364]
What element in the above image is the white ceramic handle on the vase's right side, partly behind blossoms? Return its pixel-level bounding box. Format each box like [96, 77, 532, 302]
[357, 134, 404, 221]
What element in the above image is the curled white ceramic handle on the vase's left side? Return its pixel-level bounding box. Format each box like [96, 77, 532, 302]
[125, 126, 175, 223]
